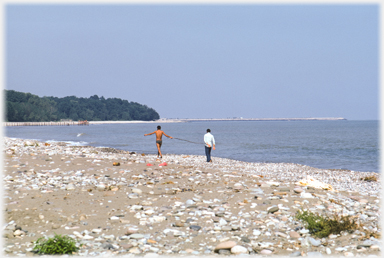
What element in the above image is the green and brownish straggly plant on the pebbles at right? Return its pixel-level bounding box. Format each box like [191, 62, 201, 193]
[296, 210, 359, 238]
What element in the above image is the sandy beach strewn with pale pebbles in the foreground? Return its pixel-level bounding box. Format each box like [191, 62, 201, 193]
[2, 137, 382, 257]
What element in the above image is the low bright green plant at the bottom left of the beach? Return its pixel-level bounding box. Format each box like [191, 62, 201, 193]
[33, 233, 79, 254]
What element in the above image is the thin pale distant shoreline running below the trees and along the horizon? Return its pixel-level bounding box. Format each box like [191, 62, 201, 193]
[3, 117, 347, 126]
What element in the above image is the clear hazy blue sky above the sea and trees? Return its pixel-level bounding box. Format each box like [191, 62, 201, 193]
[5, 3, 380, 120]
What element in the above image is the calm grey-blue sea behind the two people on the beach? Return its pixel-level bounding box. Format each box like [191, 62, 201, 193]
[4, 120, 379, 172]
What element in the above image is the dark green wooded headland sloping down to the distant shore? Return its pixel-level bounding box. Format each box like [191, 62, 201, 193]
[4, 90, 160, 122]
